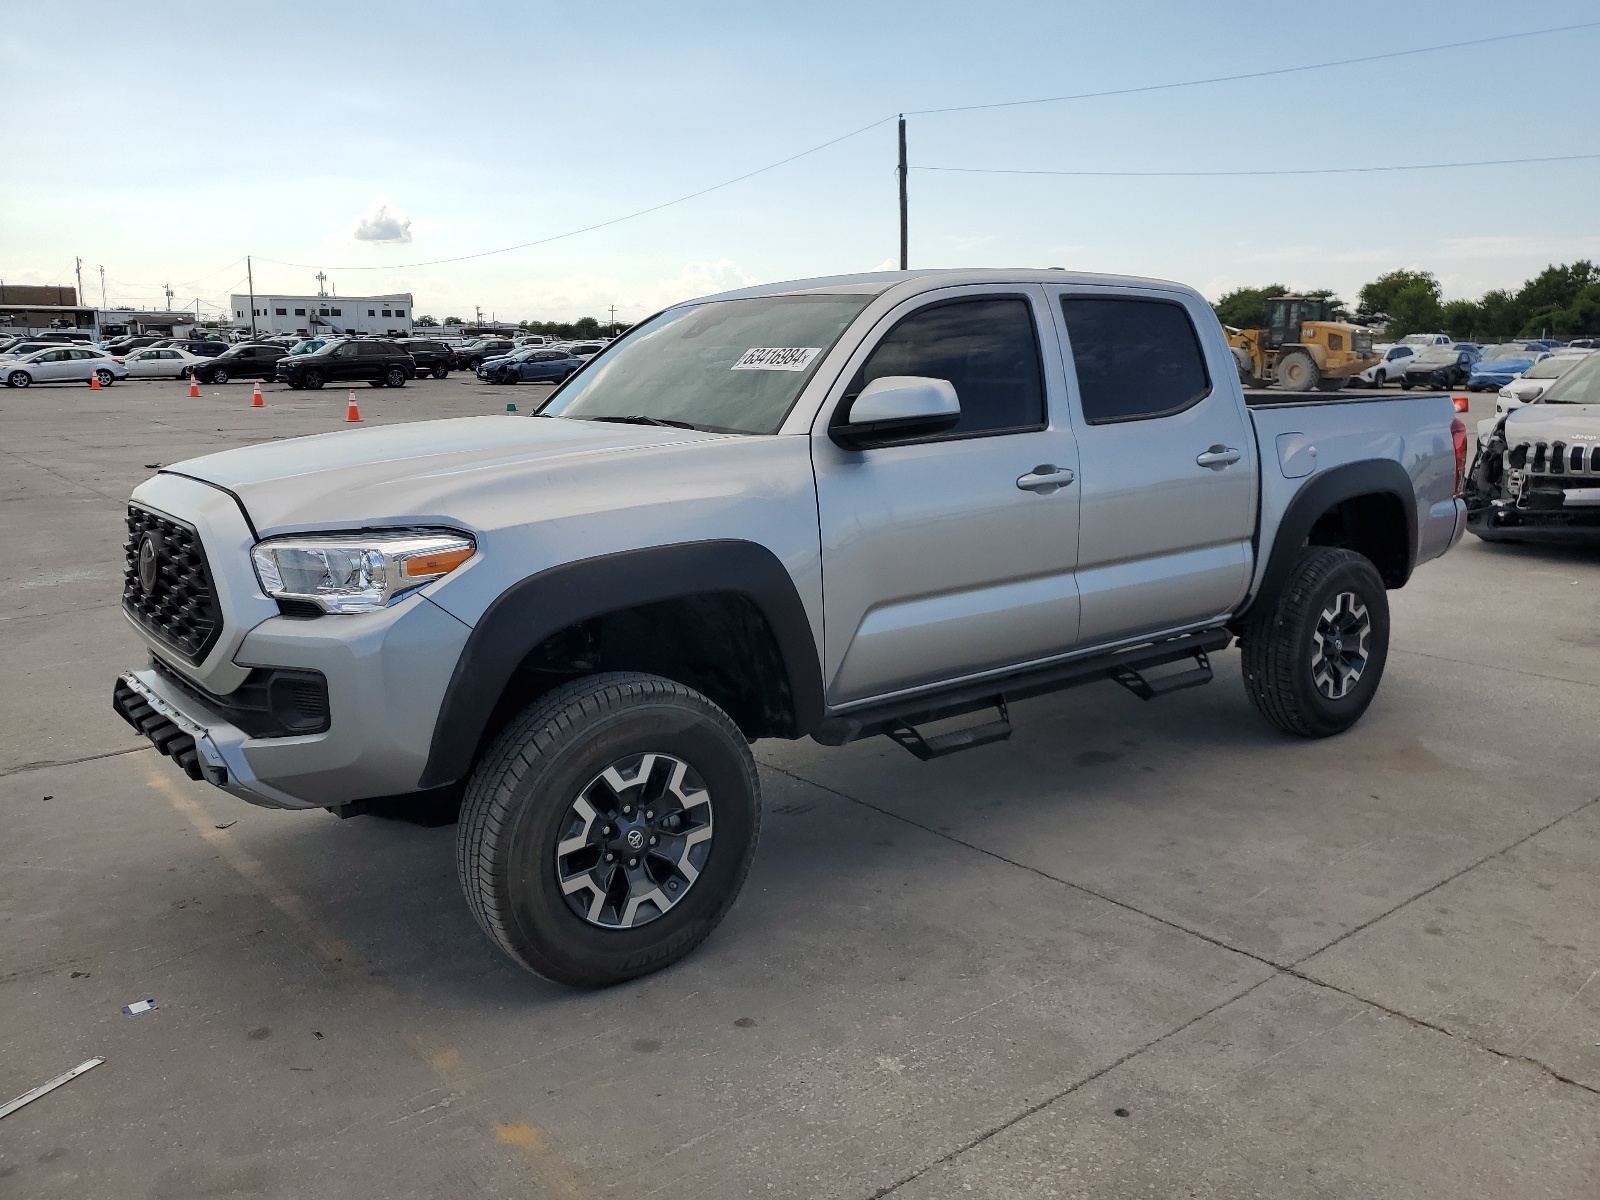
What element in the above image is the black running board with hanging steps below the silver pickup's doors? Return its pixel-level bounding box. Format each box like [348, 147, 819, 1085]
[811, 629, 1234, 762]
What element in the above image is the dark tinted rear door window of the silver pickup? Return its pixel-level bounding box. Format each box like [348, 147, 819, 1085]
[1061, 296, 1211, 426]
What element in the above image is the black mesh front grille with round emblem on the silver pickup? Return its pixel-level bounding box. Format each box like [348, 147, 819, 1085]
[122, 504, 222, 662]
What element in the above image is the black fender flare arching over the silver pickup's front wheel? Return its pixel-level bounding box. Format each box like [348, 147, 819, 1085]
[418, 539, 822, 789]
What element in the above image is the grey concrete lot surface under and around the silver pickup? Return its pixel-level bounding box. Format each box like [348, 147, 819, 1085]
[0, 378, 1600, 1200]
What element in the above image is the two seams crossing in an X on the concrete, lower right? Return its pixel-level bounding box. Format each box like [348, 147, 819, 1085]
[762, 763, 1600, 1200]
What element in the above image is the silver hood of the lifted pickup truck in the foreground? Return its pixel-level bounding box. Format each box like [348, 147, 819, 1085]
[163, 416, 730, 536]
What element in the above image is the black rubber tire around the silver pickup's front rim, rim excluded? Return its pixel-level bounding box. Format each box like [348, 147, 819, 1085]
[456, 672, 760, 987]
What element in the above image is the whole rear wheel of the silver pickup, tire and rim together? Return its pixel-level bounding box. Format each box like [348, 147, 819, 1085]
[1240, 546, 1389, 738]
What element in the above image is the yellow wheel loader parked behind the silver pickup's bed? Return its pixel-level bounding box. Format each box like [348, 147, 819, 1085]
[1227, 296, 1378, 392]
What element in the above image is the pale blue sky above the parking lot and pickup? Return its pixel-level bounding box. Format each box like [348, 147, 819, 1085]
[0, 0, 1600, 318]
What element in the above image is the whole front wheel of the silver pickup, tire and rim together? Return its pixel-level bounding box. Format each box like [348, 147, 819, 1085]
[456, 672, 760, 987]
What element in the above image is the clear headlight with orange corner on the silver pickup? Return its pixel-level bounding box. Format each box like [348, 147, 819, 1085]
[250, 530, 478, 613]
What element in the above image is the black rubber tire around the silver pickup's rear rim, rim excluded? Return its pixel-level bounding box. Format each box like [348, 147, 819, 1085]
[1238, 546, 1389, 738]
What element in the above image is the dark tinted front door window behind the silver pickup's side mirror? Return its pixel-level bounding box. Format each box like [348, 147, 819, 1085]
[850, 296, 1045, 438]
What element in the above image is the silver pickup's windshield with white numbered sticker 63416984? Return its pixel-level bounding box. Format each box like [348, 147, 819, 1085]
[542, 296, 870, 434]
